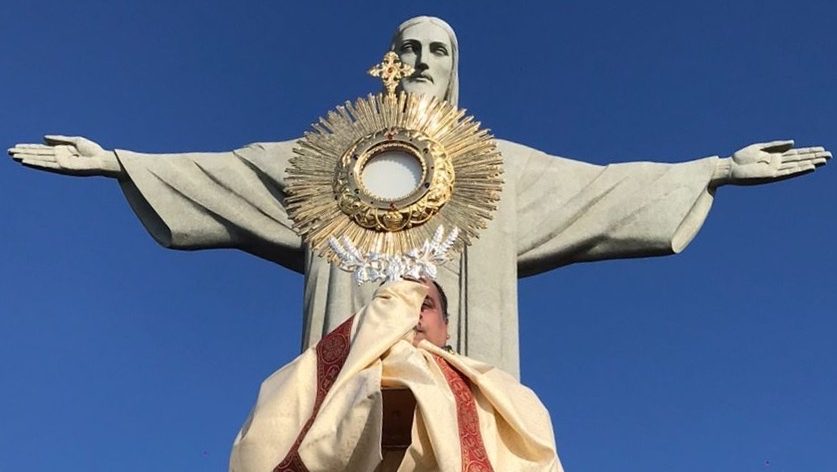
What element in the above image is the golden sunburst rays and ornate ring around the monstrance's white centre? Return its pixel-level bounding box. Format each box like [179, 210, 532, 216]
[286, 56, 502, 262]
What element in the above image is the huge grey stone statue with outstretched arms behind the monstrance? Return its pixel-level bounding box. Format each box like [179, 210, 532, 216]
[9, 17, 831, 374]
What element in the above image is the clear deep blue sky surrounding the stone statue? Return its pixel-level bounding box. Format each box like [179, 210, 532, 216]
[0, 0, 837, 472]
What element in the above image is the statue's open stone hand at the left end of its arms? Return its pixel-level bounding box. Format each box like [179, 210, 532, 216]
[8, 135, 124, 178]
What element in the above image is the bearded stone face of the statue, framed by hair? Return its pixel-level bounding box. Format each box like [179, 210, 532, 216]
[395, 22, 453, 99]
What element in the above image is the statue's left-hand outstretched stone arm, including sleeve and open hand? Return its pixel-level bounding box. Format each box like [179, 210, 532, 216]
[8, 135, 304, 272]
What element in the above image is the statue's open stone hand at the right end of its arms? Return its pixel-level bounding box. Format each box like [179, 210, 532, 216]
[712, 140, 831, 186]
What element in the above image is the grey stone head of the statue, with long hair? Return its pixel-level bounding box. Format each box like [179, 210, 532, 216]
[390, 16, 459, 105]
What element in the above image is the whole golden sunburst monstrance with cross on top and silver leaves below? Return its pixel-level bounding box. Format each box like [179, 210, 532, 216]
[286, 51, 503, 283]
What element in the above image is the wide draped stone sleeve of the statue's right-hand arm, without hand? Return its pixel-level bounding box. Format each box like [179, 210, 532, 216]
[503, 139, 720, 277]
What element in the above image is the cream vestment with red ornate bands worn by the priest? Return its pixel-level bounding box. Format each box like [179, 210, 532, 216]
[230, 281, 563, 472]
